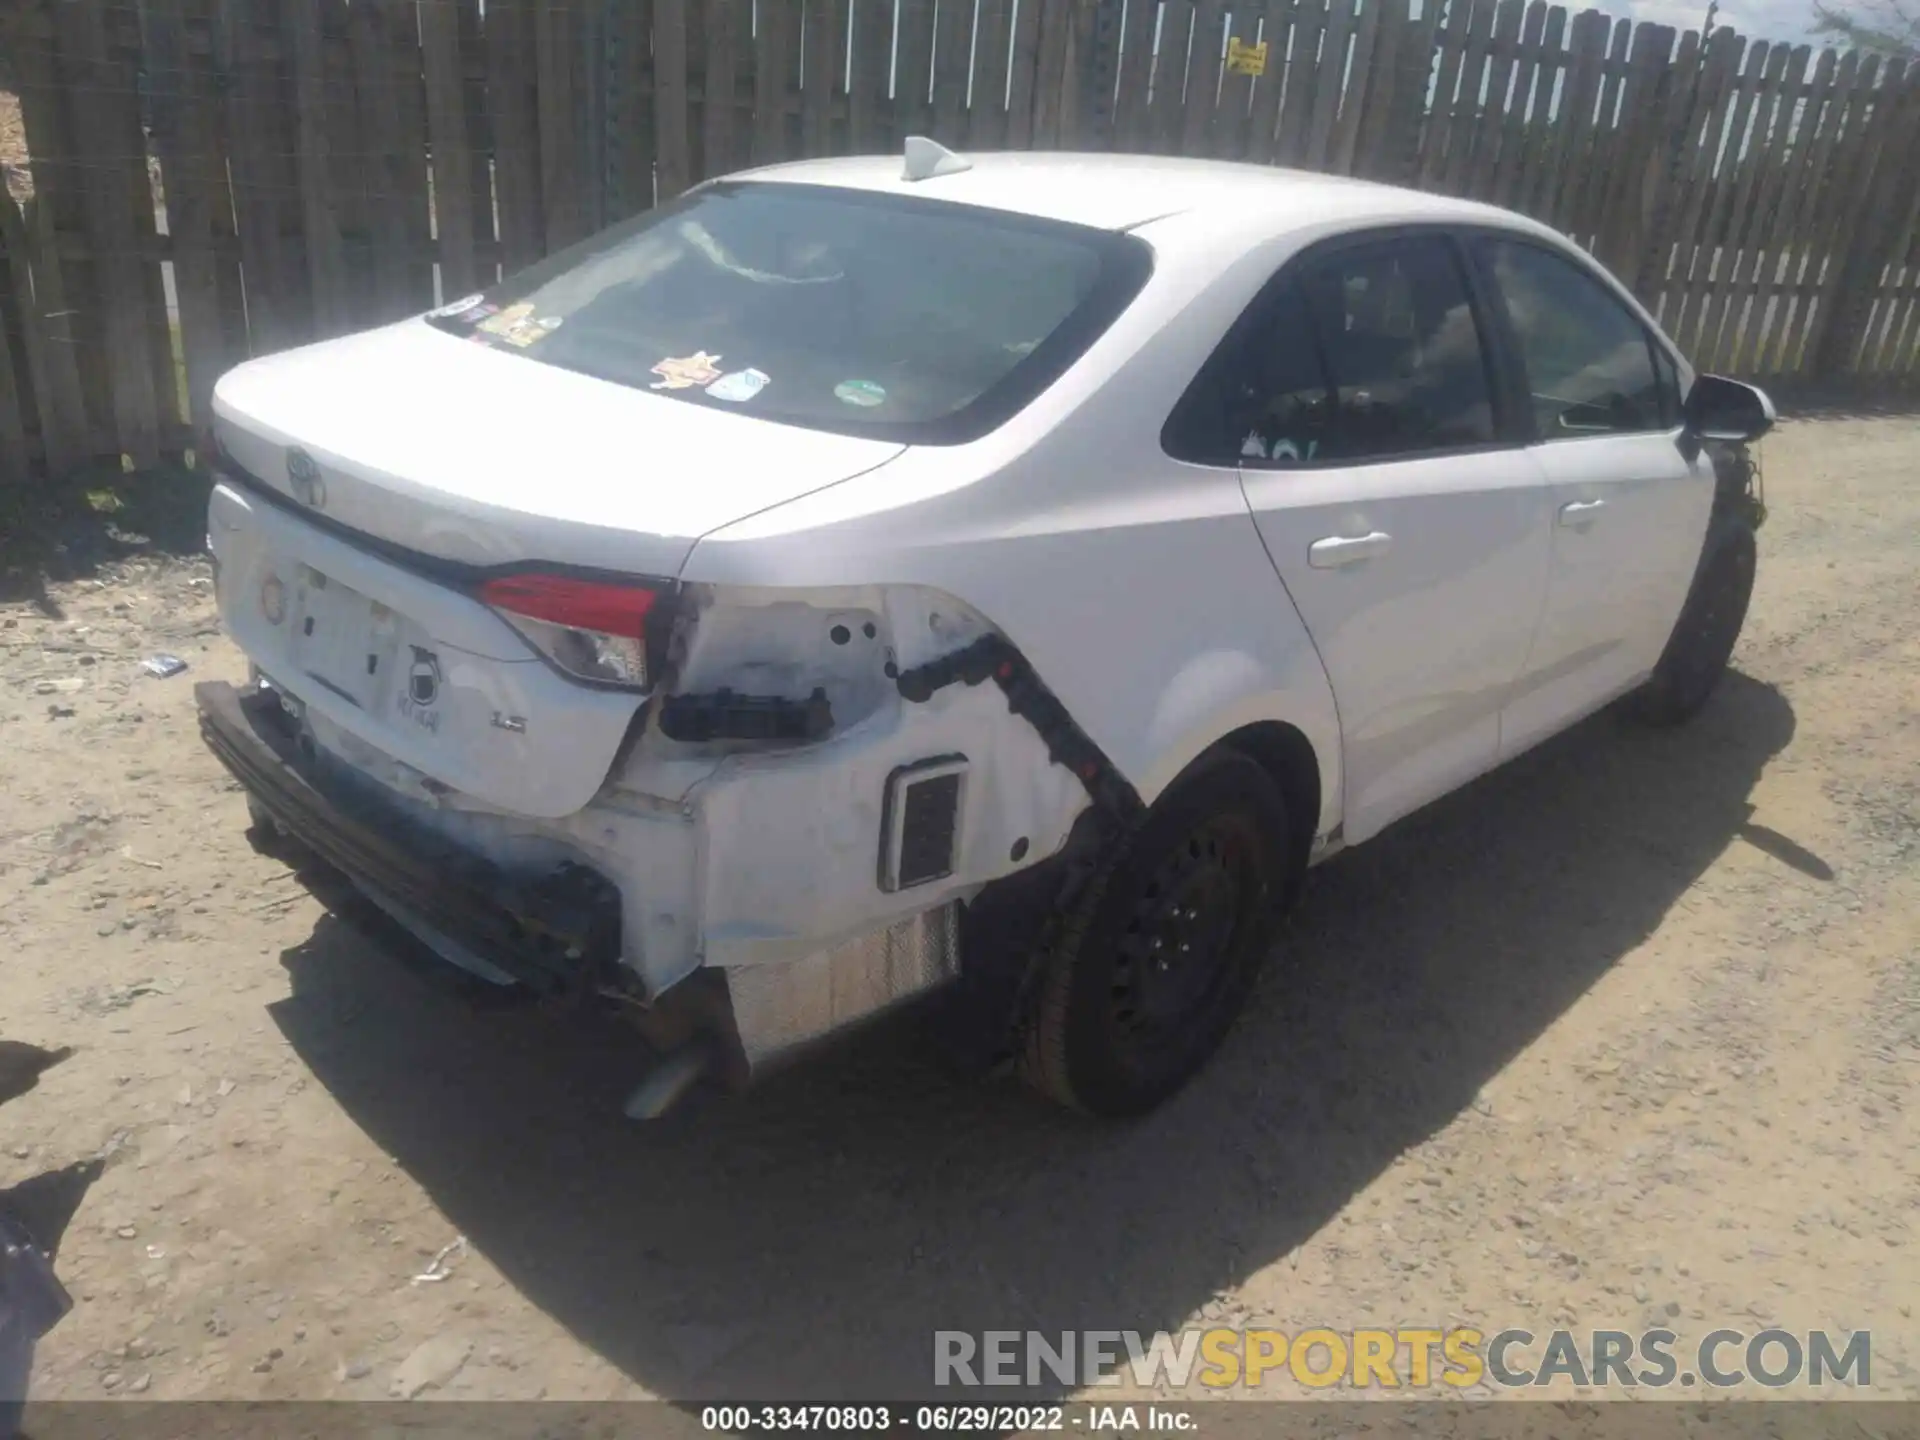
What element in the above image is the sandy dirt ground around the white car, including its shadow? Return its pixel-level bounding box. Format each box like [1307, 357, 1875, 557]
[0, 417, 1920, 1400]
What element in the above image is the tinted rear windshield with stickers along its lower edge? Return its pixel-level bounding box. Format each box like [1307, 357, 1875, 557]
[428, 182, 1152, 444]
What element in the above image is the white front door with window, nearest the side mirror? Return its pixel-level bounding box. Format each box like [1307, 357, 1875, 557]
[1475, 236, 1713, 756]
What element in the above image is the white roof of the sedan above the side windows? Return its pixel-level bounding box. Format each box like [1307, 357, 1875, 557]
[728, 150, 1536, 234]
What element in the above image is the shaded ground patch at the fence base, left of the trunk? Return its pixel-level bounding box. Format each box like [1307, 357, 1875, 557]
[0, 467, 207, 616]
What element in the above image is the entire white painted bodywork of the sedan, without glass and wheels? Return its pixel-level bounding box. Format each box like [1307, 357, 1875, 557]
[209, 154, 1735, 1082]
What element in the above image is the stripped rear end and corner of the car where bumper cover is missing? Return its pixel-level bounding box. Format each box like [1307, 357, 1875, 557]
[228, 586, 1142, 1117]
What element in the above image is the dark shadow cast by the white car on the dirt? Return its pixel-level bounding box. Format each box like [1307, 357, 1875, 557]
[275, 674, 1818, 1400]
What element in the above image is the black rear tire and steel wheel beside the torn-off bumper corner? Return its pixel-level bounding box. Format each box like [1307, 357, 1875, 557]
[1021, 749, 1304, 1119]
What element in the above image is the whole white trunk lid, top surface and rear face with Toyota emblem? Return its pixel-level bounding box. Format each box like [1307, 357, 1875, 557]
[207, 321, 902, 818]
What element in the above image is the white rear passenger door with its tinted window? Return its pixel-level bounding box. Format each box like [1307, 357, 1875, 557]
[1169, 232, 1548, 843]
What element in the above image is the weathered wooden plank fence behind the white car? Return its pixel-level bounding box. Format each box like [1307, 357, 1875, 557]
[0, 0, 1920, 480]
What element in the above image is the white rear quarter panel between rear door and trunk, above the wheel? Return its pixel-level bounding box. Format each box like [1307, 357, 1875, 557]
[684, 380, 1340, 833]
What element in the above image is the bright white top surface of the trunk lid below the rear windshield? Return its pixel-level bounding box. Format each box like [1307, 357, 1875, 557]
[213, 321, 902, 578]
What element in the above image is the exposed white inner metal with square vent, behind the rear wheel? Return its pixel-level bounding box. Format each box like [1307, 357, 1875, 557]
[612, 586, 1089, 979]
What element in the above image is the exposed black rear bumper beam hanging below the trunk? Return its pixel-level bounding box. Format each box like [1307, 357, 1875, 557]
[194, 682, 620, 996]
